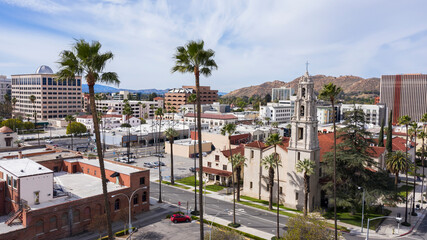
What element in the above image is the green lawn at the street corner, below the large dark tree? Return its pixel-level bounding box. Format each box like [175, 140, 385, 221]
[323, 209, 390, 230]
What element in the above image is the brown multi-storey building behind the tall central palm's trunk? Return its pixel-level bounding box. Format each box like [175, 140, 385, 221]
[165, 86, 218, 112]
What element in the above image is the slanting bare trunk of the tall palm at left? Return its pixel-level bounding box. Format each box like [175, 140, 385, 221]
[88, 85, 113, 240]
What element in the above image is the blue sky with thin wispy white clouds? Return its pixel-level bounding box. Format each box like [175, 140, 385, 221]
[0, 0, 427, 92]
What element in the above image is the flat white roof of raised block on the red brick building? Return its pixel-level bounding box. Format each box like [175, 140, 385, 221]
[0, 158, 53, 177]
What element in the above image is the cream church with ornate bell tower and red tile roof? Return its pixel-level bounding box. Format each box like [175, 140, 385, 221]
[242, 71, 321, 211]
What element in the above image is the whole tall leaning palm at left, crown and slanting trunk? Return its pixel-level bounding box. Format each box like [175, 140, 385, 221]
[58, 39, 120, 240]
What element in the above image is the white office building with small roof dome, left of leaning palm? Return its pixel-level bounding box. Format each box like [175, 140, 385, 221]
[12, 65, 82, 120]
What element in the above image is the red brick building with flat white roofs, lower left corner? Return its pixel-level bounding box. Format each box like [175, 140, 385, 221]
[0, 150, 150, 240]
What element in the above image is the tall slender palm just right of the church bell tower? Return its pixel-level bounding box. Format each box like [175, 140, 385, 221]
[319, 83, 342, 240]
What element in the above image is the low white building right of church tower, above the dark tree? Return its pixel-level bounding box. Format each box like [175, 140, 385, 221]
[340, 104, 388, 126]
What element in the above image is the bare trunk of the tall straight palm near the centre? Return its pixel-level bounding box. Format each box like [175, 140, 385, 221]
[194, 68, 204, 240]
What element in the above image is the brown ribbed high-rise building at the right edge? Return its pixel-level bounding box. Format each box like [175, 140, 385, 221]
[380, 74, 427, 124]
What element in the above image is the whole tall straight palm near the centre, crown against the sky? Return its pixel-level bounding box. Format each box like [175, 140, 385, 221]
[172, 41, 218, 235]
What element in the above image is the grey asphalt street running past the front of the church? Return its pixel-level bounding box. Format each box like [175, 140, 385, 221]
[150, 182, 287, 235]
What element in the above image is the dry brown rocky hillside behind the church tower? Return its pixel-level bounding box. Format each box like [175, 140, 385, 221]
[224, 75, 380, 97]
